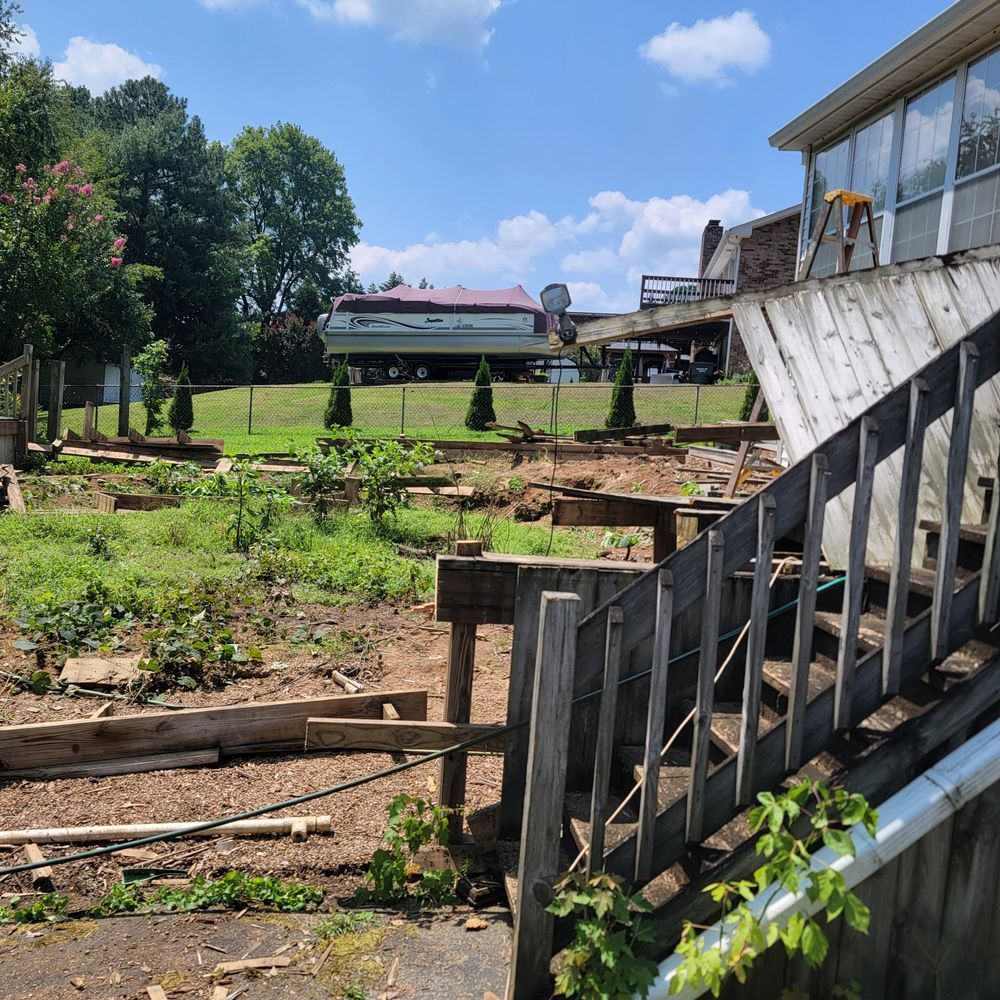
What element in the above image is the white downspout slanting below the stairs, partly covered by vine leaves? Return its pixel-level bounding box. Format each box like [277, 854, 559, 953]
[647, 720, 1000, 1000]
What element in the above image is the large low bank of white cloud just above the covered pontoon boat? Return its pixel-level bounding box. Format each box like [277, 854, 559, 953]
[351, 190, 764, 312]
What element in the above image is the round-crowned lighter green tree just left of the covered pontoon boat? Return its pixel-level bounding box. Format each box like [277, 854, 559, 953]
[226, 122, 361, 329]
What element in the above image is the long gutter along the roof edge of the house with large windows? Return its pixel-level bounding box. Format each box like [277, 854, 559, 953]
[768, 0, 1000, 150]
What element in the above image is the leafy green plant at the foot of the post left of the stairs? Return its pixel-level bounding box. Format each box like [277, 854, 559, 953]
[357, 795, 458, 906]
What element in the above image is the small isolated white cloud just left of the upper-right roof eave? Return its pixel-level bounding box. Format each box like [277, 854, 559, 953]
[639, 10, 771, 84]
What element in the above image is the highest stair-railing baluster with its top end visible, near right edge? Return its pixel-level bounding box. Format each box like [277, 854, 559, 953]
[931, 343, 979, 660]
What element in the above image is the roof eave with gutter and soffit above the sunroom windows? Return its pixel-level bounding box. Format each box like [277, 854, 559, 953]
[770, 0, 1000, 150]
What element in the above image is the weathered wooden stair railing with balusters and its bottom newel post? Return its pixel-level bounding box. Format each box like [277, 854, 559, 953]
[507, 315, 1000, 1000]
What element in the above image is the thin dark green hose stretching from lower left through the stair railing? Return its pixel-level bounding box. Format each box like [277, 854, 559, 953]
[0, 576, 845, 875]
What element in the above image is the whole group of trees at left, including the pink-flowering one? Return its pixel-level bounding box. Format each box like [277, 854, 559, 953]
[0, 0, 426, 384]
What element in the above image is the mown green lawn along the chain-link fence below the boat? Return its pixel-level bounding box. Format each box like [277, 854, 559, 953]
[54, 382, 745, 454]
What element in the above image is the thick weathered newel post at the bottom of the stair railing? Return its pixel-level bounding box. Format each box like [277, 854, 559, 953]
[506, 591, 580, 1000]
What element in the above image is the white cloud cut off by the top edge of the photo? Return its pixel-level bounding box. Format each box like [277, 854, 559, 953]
[296, 0, 501, 49]
